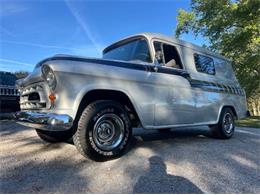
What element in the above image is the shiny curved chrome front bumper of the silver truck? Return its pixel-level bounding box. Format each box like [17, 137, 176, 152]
[15, 111, 73, 131]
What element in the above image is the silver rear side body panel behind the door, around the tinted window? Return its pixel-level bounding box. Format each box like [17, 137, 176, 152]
[182, 47, 247, 124]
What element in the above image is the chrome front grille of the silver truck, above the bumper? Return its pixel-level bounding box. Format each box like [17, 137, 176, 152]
[20, 83, 50, 110]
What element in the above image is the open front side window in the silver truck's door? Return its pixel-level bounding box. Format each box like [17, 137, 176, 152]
[154, 42, 182, 69]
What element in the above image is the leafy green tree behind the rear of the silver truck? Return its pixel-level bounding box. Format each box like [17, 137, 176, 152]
[175, 0, 260, 115]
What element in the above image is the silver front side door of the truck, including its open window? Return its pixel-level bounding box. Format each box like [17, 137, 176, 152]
[152, 41, 196, 126]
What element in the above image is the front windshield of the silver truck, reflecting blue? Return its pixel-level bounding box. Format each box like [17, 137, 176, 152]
[103, 39, 151, 62]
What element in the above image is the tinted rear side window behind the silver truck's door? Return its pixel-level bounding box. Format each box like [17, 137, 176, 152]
[194, 54, 216, 75]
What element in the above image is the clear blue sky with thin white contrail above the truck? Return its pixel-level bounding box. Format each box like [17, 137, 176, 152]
[0, 0, 207, 72]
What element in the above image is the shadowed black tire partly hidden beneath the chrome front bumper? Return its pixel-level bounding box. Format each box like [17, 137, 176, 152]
[36, 129, 72, 143]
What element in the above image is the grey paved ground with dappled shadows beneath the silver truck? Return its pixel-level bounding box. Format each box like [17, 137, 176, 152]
[0, 121, 260, 193]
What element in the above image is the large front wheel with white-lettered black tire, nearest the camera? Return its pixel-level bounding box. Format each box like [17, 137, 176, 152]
[73, 100, 132, 161]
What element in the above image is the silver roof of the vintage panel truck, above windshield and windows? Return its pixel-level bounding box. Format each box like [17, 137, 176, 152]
[103, 32, 230, 61]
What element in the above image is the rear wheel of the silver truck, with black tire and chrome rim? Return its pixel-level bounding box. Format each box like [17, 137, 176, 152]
[209, 108, 235, 139]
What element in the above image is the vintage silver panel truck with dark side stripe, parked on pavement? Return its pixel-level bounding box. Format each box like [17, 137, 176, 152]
[16, 33, 247, 160]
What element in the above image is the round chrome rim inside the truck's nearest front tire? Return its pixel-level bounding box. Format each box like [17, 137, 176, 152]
[93, 114, 125, 151]
